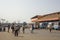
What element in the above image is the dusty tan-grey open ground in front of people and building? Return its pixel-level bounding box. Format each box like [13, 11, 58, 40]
[0, 29, 60, 40]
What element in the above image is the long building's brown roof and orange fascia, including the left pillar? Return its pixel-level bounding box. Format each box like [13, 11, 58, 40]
[31, 12, 60, 27]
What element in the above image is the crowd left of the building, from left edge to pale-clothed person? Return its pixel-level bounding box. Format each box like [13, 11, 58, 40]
[0, 22, 34, 36]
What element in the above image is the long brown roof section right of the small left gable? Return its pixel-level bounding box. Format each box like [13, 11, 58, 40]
[38, 12, 60, 22]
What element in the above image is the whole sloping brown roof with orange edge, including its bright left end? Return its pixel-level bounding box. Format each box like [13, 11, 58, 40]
[32, 12, 60, 22]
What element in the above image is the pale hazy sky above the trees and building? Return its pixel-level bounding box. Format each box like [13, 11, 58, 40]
[0, 0, 60, 22]
